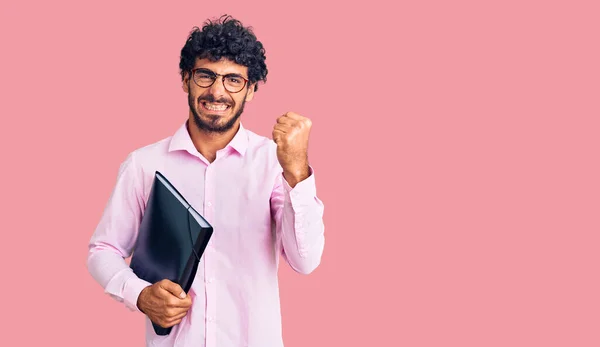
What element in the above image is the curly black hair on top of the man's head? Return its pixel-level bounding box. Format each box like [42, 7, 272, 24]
[179, 15, 268, 91]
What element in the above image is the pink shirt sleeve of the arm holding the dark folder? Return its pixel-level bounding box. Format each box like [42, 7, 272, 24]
[87, 153, 151, 312]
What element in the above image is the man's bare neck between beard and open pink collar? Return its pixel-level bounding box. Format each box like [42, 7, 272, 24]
[187, 117, 240, 163]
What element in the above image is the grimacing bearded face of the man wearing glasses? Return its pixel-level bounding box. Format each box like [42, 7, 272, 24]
[183, 59, 254, 133]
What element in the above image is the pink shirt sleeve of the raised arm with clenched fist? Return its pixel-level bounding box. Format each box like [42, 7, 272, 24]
[271, 167, 325, 274]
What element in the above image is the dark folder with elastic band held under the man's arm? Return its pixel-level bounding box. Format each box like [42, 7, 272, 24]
[129, 171, 213, 335]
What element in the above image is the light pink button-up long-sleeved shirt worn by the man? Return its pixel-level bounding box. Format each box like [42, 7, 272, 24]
[88, 124, 325, 347]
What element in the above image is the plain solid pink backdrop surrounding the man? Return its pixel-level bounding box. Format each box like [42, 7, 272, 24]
[0, 1, 600, 347]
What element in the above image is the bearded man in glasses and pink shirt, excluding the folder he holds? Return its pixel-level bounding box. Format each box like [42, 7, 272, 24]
[88, 16, 324, 347]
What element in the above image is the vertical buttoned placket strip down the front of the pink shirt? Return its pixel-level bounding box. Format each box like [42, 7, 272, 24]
[203, 165, 217, 347]
